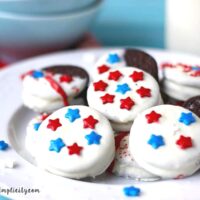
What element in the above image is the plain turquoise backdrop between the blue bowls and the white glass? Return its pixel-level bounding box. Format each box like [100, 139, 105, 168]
[92, 0, 165, 48]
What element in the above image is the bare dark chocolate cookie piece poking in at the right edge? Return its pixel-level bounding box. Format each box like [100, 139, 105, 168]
[183, 95, 200, 117]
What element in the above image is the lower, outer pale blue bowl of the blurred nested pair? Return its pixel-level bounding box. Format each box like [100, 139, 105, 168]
[0, 0, 102, 60]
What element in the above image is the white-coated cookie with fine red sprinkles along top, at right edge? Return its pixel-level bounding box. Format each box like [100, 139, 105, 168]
[161, 63, 200, 101]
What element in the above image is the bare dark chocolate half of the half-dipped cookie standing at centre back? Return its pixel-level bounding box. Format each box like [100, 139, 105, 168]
[124, 49, 159, 81]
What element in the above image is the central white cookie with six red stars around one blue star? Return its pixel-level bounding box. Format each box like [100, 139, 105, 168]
[87, 67, 162, 131]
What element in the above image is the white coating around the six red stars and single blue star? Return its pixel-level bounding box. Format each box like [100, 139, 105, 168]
[87, 67, 161, 123]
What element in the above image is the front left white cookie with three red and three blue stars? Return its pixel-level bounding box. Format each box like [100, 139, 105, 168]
[35, 106, 115, 179]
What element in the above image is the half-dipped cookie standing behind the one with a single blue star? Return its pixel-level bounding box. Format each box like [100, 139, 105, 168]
[94, 49, 158, 81]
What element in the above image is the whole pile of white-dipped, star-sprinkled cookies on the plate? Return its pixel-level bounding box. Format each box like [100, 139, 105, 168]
[22, 49, 200, 181]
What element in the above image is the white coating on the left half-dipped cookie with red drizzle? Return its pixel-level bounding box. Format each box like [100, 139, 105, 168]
[22, 71, 87, 113]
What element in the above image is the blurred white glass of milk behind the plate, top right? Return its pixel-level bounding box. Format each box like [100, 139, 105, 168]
[165, 0, 200, 55]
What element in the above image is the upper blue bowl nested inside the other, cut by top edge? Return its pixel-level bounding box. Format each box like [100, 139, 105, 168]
[0, 0, 95, 15]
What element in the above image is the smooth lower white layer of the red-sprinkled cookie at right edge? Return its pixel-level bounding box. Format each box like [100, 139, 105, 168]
[162, 79, 200, 101]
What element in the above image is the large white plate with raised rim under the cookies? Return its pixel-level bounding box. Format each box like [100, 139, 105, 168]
[0, 49, 200, 200]
